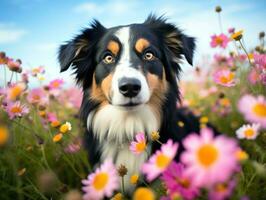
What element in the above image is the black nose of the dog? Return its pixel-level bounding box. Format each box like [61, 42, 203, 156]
[118, 78, 141, 98]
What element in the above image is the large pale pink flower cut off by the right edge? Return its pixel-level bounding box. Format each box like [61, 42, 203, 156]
[238, 94, 266, 128]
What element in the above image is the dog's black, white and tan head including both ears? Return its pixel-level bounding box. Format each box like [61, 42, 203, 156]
[59, 16, 195, 108]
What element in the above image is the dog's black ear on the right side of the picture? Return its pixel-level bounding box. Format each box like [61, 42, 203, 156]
[144, 15, 195, 65]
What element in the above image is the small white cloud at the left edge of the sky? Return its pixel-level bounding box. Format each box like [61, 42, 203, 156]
[0, 24, 27, 44]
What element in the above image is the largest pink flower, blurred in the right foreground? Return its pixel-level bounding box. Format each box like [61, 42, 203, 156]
[181, 128, 238, 187]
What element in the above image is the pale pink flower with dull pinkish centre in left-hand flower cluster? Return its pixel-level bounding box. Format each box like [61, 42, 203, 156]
[27, 88, 48, 104]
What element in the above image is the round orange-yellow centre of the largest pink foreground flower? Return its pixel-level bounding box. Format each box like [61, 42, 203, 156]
[197, 144, 218, 167]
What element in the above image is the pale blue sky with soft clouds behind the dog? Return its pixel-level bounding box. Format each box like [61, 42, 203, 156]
[0, 0, 266, 85]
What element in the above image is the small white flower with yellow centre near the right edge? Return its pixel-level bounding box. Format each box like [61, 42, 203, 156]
[236, 124, 260, 140]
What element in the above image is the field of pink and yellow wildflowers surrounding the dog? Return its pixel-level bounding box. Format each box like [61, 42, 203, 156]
[0, 7, 266, 200]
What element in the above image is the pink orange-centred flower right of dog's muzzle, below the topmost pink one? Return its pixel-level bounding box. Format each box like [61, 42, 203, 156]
[213, 69, 236, 87]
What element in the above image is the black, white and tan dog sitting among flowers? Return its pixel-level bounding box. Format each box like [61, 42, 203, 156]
[58, 15, 204, 191]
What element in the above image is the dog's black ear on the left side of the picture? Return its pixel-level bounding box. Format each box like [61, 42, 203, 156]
[58, 20, 106, 72]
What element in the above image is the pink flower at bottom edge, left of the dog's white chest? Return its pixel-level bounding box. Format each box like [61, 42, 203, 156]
[82, 160, 119, 200]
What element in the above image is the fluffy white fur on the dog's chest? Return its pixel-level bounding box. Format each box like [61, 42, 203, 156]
[87, 105, 160, 191]
